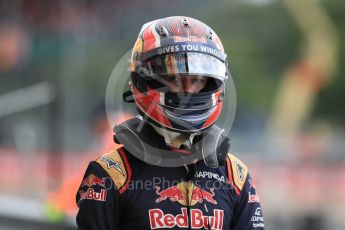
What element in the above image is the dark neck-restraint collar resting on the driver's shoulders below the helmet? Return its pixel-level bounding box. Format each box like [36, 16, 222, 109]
[114, 118, 230, 168]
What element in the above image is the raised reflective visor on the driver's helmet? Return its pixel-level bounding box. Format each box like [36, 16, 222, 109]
[144, 52, 227, 82]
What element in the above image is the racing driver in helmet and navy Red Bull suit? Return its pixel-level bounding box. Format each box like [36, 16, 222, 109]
[77, 16, 264, 230]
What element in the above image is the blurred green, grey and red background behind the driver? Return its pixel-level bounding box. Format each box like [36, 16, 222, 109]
[0, 0, 345, 230]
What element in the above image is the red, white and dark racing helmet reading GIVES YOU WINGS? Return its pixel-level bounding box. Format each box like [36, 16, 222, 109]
[130, 16, 228, 133]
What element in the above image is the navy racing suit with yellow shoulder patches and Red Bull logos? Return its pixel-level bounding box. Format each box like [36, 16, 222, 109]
[76, 126, 264, 230]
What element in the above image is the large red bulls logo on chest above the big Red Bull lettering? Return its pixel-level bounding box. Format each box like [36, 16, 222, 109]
[156, 182, 217, 206]
